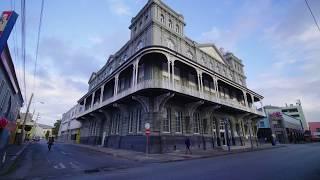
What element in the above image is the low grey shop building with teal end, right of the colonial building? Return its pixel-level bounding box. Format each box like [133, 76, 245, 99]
[258, 105, 304, 143]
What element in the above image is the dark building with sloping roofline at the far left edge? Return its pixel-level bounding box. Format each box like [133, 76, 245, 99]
[0, 44, 23, 150]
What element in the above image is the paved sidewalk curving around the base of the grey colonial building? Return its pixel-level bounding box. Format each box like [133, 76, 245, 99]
[66, 143, 286, 163]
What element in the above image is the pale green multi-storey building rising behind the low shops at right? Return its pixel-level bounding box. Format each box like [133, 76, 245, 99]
[281, 100, 309, 130]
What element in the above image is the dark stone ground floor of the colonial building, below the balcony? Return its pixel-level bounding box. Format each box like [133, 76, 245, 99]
[77, 91, 259, 153]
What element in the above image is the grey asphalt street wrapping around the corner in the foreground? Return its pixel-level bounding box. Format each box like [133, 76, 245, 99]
[2, 143, 320, 180]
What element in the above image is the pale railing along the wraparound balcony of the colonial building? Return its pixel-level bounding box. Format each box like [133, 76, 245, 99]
[77, 79, 264, 117]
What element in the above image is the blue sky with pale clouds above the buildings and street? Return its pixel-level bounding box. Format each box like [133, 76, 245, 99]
[0, 0, 320, 125]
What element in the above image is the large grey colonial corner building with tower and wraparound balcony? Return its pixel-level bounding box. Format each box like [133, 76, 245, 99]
[77, 0, 264, 153]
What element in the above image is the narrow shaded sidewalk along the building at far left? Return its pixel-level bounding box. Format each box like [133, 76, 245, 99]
[0, 142, 29, 176]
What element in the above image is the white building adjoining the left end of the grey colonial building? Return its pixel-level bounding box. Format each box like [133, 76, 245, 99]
[58, 106, 81, 143]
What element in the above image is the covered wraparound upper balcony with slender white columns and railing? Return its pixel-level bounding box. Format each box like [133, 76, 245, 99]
[77, 47, 264, 117]
